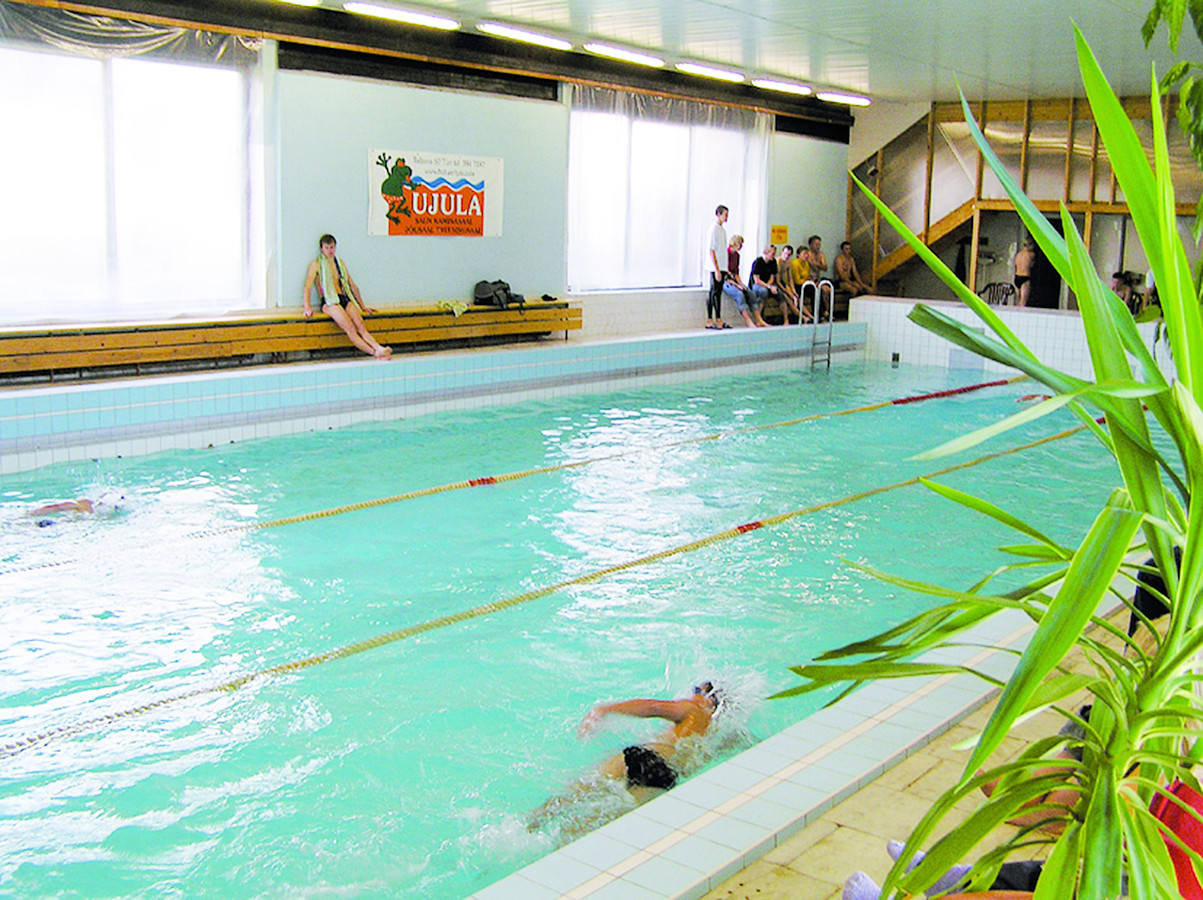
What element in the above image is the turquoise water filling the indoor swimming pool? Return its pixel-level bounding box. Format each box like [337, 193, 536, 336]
[0, 366, 1116, 899]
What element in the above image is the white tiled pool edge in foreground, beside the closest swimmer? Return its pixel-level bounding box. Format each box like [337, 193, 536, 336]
[469, 579, 1131, 900]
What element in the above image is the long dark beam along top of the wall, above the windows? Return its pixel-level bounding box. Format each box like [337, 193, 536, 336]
[17, 0, 853, 129]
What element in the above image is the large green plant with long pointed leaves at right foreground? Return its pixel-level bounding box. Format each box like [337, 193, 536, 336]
[778, 31, 1203, 900]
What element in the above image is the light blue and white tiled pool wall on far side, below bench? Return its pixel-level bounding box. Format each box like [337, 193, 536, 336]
[0, 322, 866, 474]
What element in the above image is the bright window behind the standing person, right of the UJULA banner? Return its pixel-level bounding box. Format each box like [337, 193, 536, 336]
[568, 87, 770, 291]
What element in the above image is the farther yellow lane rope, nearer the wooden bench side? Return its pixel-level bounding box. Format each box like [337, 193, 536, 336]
[0, 375, 1027, 575]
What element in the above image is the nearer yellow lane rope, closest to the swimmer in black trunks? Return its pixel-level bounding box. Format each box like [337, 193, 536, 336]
[0, 413, 1086, 759]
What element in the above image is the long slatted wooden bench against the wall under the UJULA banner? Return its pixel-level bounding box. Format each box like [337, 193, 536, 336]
[0, 301, 581, 377]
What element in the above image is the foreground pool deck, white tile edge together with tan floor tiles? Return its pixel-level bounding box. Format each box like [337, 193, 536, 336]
[472, 584, 1124, 900]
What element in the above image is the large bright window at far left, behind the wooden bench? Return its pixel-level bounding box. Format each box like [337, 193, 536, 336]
[0, 8, 263, 322]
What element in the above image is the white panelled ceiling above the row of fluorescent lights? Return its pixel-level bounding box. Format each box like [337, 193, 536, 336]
[389, 0, 1203, 101]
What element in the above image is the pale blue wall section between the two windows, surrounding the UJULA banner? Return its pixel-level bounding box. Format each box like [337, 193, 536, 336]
[277, 71, 568, 306]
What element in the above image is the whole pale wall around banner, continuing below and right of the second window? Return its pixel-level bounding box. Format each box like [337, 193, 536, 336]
[275, 71, 847, 339]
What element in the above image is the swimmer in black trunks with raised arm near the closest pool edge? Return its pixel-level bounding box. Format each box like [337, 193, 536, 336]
[528, 681, 723, 830]
